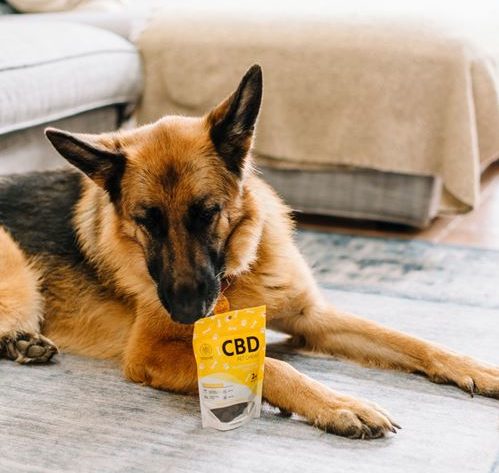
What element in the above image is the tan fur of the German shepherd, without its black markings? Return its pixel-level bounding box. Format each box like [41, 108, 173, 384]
[0, 67, 499, 438]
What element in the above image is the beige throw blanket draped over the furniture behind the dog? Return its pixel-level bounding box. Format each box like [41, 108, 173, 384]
[138, 2, 499, 211]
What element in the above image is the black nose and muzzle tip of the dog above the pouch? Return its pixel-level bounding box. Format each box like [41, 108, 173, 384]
[162, 277, 216, 324]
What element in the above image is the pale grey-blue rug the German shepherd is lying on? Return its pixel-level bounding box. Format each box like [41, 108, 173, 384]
[0, 233, 499, 473]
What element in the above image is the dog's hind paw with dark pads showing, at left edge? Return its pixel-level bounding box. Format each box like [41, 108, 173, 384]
[0, 333, 59, 364]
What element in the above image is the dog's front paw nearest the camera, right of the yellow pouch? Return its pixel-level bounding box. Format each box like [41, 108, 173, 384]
[313, 399, 400, 439]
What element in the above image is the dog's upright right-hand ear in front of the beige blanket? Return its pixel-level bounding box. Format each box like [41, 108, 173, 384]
[207, 65, 263, 177]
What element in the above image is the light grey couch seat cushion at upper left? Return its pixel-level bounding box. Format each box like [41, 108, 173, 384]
[0, 17, 141, 134]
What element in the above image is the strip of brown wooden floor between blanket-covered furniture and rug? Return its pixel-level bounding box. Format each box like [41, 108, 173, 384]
[297, 162, 499, 250]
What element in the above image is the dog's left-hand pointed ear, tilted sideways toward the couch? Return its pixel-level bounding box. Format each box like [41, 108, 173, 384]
[45, 128, 125, 201]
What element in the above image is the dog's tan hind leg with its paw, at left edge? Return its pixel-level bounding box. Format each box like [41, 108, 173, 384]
[0, 227, 57, 364]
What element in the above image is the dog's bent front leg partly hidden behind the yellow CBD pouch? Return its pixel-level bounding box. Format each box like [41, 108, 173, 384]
[124, 302, 396, 438]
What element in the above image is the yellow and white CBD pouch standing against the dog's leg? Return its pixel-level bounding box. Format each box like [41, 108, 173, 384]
[192, 306, 265, 430]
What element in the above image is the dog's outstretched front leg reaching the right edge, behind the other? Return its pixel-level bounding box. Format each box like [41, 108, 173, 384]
[273, 301, 499, 398]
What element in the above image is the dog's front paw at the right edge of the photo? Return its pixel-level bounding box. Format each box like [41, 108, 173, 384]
[429, 354, 499, 399]
